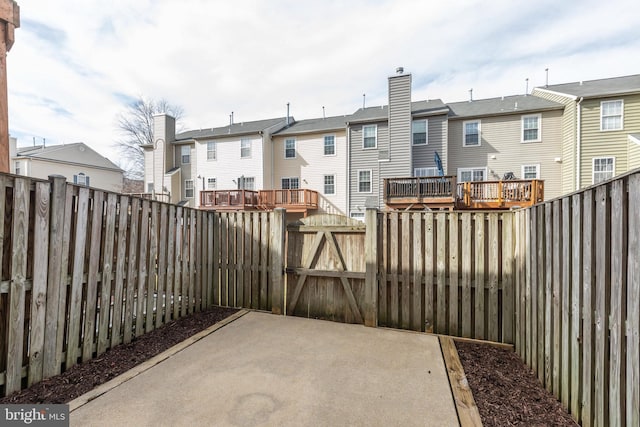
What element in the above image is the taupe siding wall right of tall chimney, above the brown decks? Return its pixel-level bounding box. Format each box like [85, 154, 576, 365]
[448, 110, 562, 199]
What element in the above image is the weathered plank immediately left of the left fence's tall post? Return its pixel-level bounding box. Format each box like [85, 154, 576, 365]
[27, 182, 50, 385]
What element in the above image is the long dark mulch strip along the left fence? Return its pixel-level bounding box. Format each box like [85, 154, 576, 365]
[0, 307, 238, 404]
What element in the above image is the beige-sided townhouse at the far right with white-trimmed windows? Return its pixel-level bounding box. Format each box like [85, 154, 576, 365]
[532, 74, 640, 193]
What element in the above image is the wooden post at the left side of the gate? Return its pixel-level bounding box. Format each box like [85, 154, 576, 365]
[269, 208, 287, 314]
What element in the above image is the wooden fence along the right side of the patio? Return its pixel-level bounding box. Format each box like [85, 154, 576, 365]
[515, 171, 640, 426]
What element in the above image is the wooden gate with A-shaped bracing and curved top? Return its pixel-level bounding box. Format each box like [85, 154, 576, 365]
[286, 214, 365, 323]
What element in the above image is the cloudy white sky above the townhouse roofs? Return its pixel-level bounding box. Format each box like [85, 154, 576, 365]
[7, 0, 640, 171]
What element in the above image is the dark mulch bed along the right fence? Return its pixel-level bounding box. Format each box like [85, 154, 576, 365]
[456, 342, 577, 427]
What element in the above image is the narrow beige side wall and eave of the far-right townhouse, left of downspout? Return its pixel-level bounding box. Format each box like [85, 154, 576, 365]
[533, 89, 577, 193]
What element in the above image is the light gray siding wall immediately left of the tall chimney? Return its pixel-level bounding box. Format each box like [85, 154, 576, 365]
[348, 122, 389, 212]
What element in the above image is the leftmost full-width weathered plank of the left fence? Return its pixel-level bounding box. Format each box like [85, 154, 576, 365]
[3, 178, 30, 395]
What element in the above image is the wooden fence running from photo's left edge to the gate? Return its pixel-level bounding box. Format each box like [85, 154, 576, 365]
[0, 175, 284, 395]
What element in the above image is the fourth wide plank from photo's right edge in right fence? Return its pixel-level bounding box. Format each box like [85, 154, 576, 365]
[581, 190, 596, 427]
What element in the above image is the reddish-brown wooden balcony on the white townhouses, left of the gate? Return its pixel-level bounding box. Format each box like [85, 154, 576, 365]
[200, 189, 318, 216]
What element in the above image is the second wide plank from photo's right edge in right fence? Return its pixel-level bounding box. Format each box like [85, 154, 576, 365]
[607, 180, 624, 426]
